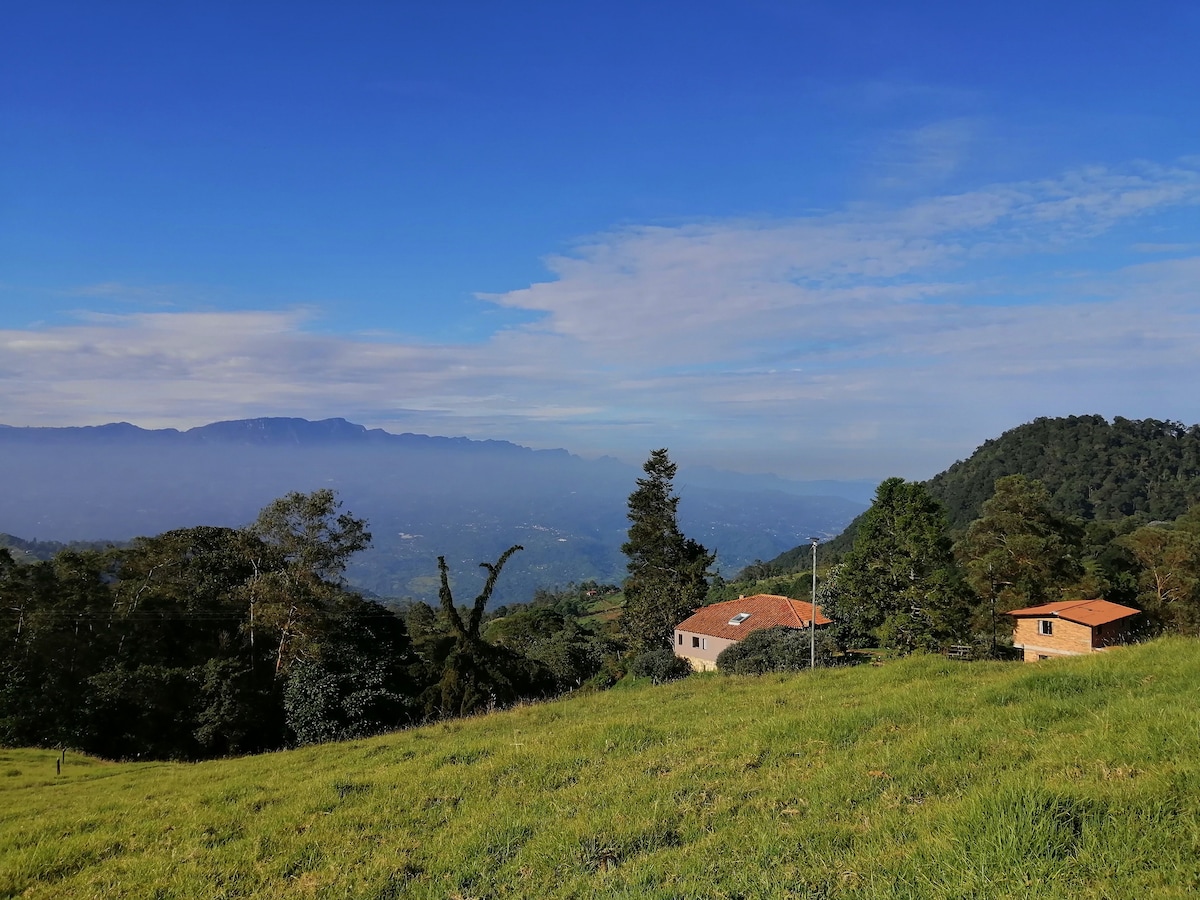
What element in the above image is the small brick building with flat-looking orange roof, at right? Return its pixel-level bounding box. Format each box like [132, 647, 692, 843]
[1008, 600, 1140, 662]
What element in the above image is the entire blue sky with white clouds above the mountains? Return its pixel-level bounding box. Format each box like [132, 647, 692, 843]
[0, 0, 1200, 479]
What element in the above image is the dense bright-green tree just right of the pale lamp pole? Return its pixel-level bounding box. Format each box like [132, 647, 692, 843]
[823, 478, 968, 652]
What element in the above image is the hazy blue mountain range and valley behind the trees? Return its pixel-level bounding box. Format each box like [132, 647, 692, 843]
[0, 419, 875, 602]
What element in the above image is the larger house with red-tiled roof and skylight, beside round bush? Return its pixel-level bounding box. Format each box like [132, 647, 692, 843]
[673, 594, 830, 672]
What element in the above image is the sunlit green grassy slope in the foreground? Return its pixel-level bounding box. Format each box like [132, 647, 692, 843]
[0, 638, 1200, 899]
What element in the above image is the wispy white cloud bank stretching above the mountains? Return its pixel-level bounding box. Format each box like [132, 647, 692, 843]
[0, 164, 1200, 478]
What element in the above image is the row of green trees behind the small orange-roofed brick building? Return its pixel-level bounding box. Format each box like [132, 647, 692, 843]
[817, 475, 1200, 653]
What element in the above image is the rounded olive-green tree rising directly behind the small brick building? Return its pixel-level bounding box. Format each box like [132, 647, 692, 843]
[955, 475, 1084, 612]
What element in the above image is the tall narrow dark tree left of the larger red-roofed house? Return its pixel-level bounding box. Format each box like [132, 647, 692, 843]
[620, 449, 715, 652]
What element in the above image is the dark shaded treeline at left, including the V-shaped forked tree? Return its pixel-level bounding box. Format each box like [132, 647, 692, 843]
[0, 490, 620, 760]
